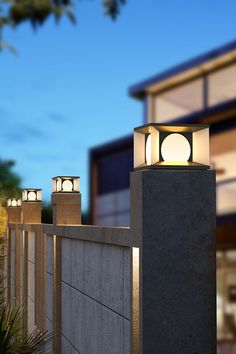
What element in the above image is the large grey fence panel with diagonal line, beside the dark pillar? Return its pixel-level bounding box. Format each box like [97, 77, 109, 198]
[61, 238, 131, 354]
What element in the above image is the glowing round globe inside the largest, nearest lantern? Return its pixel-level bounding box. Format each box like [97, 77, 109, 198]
[161, 133, 191, 162]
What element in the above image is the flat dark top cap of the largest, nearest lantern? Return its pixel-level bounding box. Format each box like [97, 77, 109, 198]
[134, 123, 210, 133]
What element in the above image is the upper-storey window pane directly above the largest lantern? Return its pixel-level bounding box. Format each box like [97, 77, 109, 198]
[154, 79, 203, 123]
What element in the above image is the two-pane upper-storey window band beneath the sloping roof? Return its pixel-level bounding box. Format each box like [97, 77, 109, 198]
[149, 64, 236, 123]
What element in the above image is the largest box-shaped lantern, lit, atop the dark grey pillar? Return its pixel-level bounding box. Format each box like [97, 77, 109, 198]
[134, 123, 210, 169]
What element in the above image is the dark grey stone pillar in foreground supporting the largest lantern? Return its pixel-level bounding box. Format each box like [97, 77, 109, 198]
[131, 169, 216, 354]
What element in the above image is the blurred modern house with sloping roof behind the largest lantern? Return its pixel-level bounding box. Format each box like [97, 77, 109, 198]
[90, 41, 236, 348]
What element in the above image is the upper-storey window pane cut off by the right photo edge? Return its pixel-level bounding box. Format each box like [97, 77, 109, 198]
[208, 64, 236, 106]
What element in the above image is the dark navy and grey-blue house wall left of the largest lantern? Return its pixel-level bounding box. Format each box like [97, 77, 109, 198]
[90, 136, 133, 226]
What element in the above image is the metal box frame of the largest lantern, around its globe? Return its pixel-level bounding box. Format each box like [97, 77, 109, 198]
[134, 123, 210, 170]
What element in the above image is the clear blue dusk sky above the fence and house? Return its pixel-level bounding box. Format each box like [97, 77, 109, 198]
[0, 0, 236, 209]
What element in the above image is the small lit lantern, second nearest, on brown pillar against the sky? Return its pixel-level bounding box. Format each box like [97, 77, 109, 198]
[52, 176, 80, 193]
